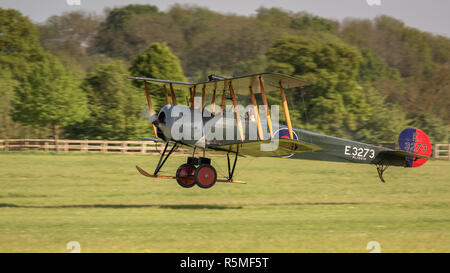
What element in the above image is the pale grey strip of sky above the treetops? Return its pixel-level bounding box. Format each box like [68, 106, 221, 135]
[0, 0, 450, 37]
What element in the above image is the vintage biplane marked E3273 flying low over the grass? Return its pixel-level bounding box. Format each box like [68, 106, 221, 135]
[130, 73, 431, 188]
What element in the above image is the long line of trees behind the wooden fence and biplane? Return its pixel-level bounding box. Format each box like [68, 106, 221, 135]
[0, 5, 450, 142]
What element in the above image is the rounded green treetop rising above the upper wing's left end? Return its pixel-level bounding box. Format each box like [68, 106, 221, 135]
[130, 43, 187, 108]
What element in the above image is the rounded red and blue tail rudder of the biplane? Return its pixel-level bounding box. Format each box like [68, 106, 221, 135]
[398, 128, 431, 167]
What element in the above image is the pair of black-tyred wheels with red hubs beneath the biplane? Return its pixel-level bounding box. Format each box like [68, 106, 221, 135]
[176, 157, 217, 189]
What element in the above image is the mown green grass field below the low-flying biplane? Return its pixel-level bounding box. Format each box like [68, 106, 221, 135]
[0, 152, 450, 252]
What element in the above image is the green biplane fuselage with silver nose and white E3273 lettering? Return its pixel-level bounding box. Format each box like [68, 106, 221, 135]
[154, 105, 405, 166]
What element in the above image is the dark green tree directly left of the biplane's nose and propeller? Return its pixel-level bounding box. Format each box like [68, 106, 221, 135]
[66, 61, 151, 139]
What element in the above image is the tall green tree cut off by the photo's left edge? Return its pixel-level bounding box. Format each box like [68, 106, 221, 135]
[0, 8, 78, 137]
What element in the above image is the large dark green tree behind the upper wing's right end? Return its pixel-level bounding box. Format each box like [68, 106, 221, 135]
[267, 37, 368, 137]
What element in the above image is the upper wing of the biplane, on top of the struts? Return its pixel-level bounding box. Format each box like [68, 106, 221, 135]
[129, 72, 307, 95]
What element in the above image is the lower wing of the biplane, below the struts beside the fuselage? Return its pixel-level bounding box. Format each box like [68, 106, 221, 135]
[208, 138, 322, 157]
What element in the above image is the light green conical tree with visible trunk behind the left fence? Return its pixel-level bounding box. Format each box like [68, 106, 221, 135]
[13, 53, 88, 140]
